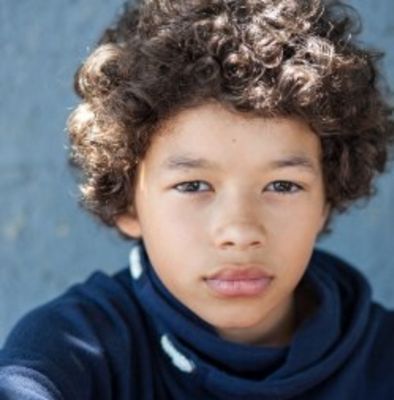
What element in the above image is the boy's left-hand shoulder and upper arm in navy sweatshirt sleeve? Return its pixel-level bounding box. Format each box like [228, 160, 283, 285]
[0, 269, 148, 399]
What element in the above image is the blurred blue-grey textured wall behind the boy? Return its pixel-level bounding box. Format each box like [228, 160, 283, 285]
[0, 0, 394, 345]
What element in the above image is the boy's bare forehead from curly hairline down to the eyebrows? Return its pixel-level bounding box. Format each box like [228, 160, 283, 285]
[146, 103, 320, 169]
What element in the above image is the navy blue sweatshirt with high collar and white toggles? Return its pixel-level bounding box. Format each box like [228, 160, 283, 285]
[0, 242, 394, 400]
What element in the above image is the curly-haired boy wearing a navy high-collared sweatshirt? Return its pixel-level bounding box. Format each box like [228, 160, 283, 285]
[0, 0, 394, 400]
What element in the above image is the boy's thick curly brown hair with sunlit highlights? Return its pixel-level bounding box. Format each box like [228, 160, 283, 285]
[68, 0, 394, 233]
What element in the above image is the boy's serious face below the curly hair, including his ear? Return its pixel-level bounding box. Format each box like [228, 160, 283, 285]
[117, 103, 328, 344]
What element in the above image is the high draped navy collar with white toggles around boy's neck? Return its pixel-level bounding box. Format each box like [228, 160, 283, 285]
[130, 241, 370, 399]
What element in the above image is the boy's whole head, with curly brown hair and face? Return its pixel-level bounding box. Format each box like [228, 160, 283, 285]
[69, 0, 394, 342]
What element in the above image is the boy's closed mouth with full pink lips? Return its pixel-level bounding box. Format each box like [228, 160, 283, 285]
[204, 266, 274, 297]
